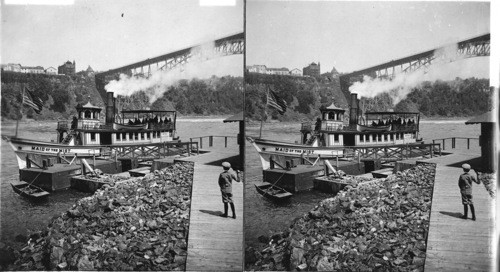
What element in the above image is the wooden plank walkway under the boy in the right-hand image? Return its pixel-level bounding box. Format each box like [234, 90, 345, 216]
[425, 154, 495, 272]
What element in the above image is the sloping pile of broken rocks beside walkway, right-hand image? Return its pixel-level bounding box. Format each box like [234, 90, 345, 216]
[247, 164, 435, 271]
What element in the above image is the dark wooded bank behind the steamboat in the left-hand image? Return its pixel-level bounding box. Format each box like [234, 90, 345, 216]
[1, 71, 243, 120]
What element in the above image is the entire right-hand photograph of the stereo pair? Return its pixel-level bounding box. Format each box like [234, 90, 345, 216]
[245, 0, 498, 271]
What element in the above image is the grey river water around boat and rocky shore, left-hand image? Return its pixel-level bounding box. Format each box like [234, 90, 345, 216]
[0, 117, 239, 246]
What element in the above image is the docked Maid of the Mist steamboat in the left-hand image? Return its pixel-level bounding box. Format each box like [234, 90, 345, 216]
[7, 92, 179, 169]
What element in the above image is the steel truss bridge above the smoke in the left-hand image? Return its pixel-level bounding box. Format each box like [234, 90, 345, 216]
[95, 32, 245, 101]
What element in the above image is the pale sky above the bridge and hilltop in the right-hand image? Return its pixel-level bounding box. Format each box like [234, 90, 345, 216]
[246, 0, 490, 82]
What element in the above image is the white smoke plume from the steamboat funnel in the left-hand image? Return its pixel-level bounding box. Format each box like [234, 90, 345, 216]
[105, 42, 225, 103]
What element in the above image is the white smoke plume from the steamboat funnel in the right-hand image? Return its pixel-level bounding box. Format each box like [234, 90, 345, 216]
[349, 44, 480, 105]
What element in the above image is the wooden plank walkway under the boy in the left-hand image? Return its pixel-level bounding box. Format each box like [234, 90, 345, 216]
[178, 151, 243, 271]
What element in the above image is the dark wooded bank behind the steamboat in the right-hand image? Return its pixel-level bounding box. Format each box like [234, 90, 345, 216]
[245, 73, 494, 121]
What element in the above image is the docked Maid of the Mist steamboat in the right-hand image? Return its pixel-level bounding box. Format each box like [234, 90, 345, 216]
[247, 93, 421, 169]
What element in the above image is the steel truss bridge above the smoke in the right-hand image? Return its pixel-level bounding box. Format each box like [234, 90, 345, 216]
[340, 33, 490, 98]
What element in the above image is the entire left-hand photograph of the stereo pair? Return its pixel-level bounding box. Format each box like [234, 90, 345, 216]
[0, 0, 244, 271]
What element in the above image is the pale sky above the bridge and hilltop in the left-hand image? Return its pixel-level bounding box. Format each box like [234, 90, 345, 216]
[0, 0, 243, 76]
